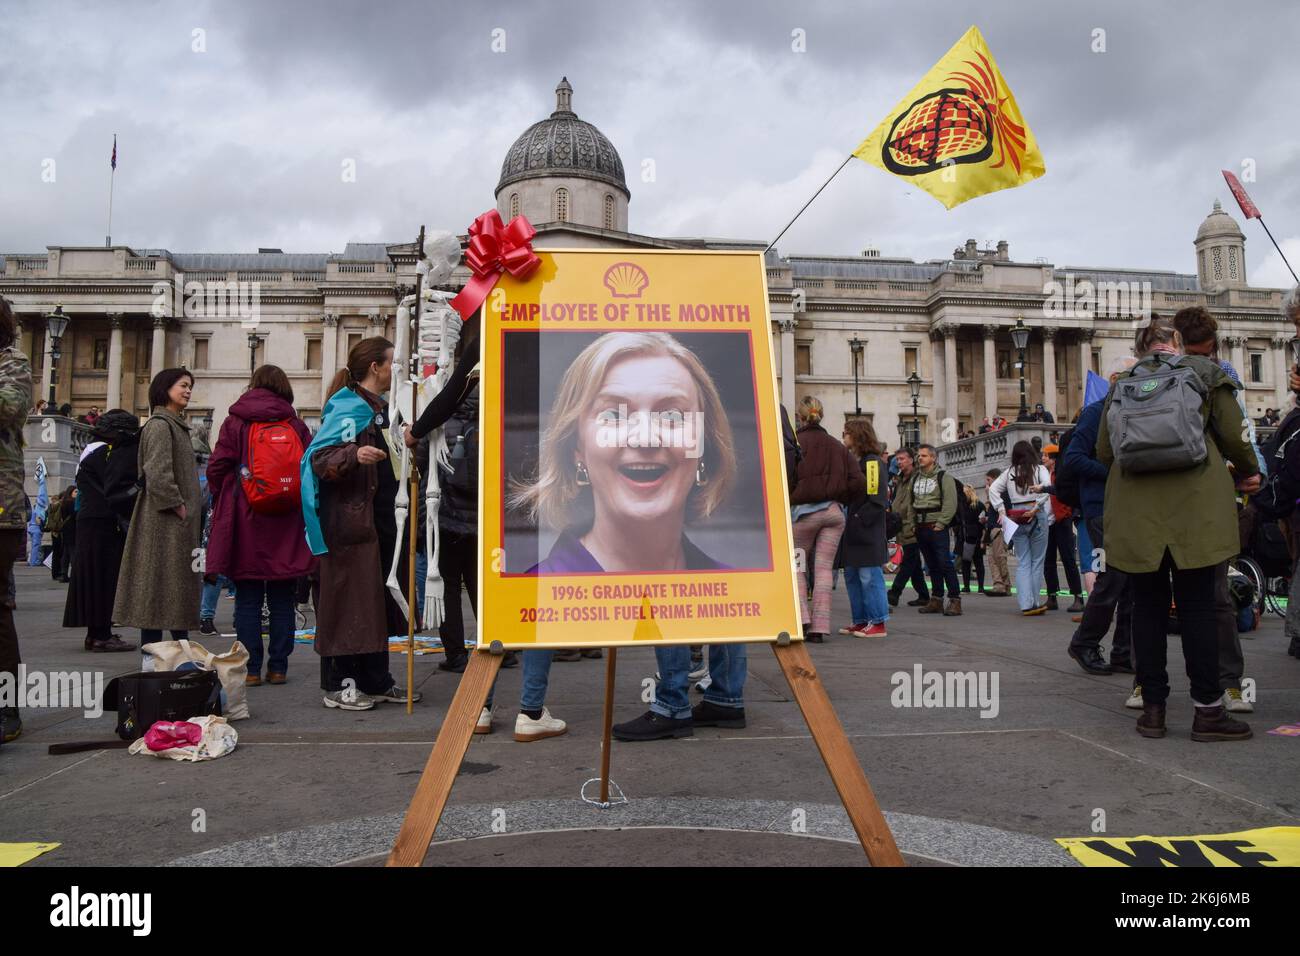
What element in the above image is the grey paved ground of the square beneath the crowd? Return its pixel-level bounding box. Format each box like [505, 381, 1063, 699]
[0, 568, 1300, 866]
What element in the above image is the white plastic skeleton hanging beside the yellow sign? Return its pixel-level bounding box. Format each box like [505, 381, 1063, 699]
[387, 233, 462, 628]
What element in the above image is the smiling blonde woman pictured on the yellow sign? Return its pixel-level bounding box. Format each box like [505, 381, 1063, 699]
[508, 332, 736, 575]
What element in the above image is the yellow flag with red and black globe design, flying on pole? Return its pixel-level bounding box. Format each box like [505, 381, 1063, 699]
[853, 26, 1047, 209]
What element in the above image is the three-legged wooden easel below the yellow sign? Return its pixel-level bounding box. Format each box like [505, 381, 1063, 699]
[386, 633, 904, 866]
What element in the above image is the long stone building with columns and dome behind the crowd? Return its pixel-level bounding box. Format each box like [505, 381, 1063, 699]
[0, 79, 1292, 489]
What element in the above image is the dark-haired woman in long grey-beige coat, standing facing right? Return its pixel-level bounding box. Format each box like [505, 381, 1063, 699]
[113, 368, 203, 648]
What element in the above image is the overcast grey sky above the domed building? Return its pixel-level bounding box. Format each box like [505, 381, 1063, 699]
[0, 0, 1300, 286]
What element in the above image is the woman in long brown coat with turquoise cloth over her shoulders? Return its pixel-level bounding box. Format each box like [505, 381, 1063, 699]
[303, 337, 420, 710]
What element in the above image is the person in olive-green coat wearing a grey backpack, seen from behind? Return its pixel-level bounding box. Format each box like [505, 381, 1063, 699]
[1097, 315, 1260, 741]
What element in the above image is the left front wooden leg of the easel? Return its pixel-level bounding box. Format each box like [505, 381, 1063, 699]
[386, 650, 503, 866]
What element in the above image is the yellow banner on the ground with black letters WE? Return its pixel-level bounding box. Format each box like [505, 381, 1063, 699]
[1057, 826, 1300, 866]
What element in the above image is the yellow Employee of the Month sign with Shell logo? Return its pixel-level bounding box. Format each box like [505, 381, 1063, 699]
[478, 250, 800, 648]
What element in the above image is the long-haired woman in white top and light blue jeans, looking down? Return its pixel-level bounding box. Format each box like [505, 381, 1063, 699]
[988, 441, 1053, 618]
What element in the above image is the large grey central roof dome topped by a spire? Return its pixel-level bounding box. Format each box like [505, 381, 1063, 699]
[497, 77, 632, 196]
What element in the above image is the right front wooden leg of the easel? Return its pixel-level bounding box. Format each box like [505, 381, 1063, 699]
[772, 641, 905, 866]
